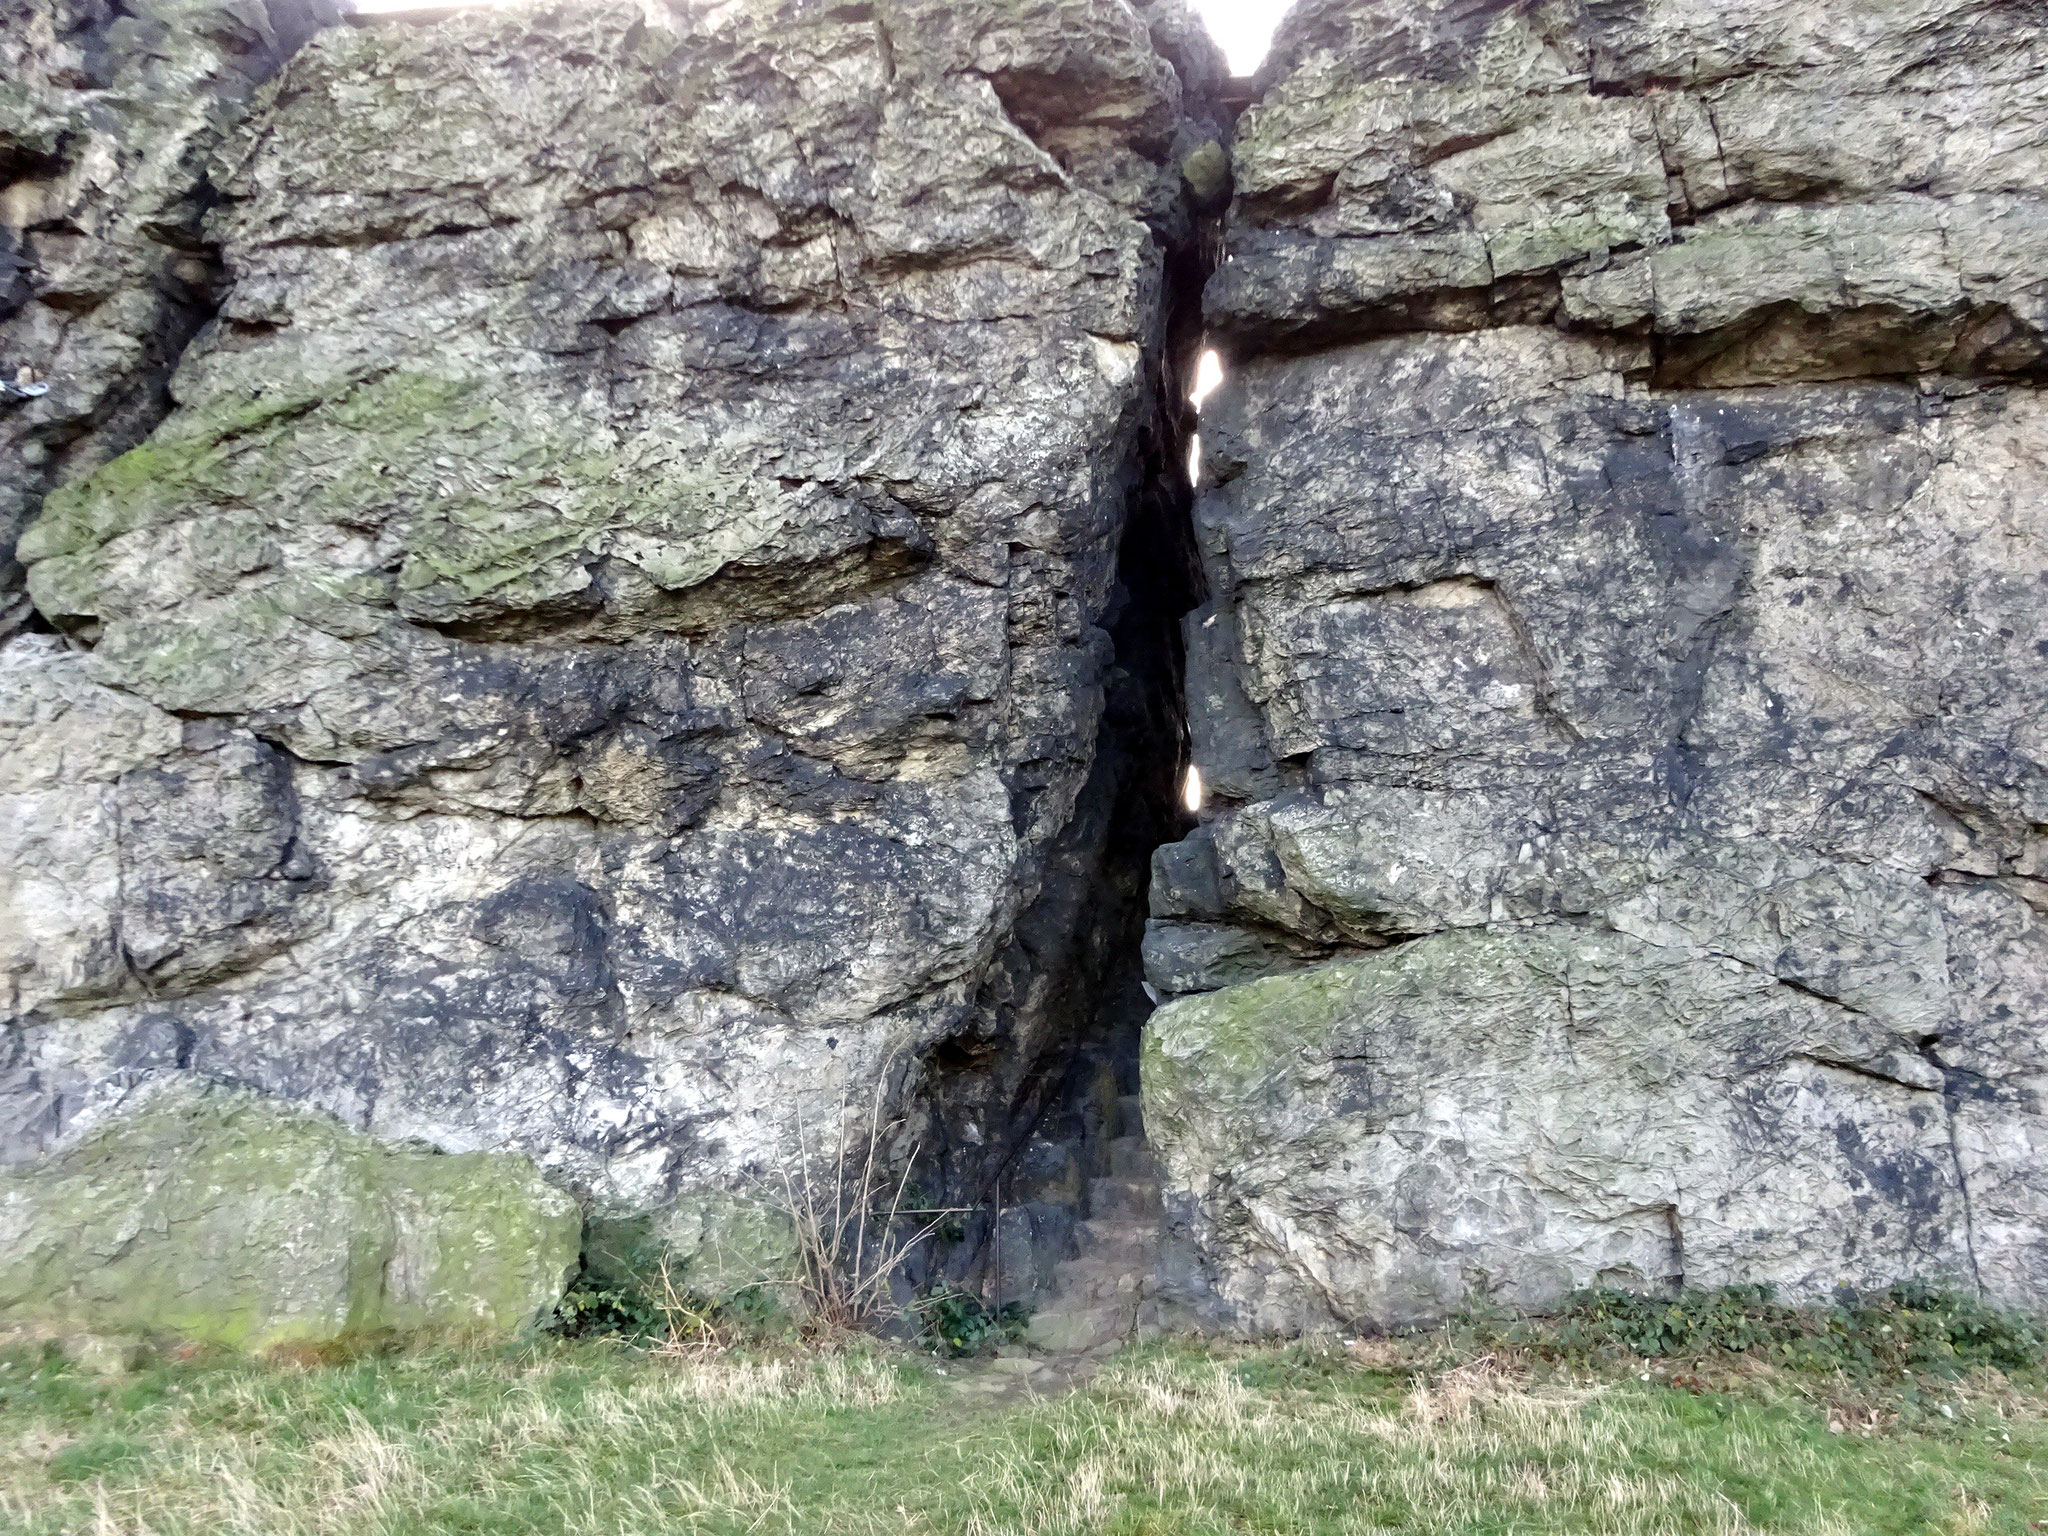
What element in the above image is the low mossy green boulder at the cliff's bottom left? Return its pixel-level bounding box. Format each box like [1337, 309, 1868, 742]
[0, 1083, 582, 1350]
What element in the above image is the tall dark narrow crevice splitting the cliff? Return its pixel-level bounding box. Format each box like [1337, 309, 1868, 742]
[905, 228, 1212, 1305]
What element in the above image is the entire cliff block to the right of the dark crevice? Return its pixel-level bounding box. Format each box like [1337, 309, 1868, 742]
[1145, 0, 2048, 1329]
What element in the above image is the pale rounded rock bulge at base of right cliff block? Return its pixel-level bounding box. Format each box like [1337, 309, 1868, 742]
[1145, 926, 1968, 1329]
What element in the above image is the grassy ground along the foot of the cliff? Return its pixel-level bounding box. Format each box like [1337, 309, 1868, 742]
[0, 1337, 2048, 1536]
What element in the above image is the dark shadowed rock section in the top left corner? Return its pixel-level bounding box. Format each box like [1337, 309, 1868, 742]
[0, 0, 340, 639]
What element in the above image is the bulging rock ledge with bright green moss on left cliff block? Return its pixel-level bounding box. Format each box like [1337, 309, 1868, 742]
[18, 371, 786, 663]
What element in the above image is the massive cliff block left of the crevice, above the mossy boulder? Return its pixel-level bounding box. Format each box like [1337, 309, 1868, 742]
[0, 0, 1221, 1327]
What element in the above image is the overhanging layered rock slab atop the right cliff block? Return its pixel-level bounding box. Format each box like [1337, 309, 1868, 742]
[1210, 0, 2048, 385]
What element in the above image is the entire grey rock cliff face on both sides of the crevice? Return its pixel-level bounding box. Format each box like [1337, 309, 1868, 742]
[0, 0, 2048, 1343]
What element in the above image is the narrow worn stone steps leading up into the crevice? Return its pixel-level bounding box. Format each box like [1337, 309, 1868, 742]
[1024, 1094, 1161, 1354]
